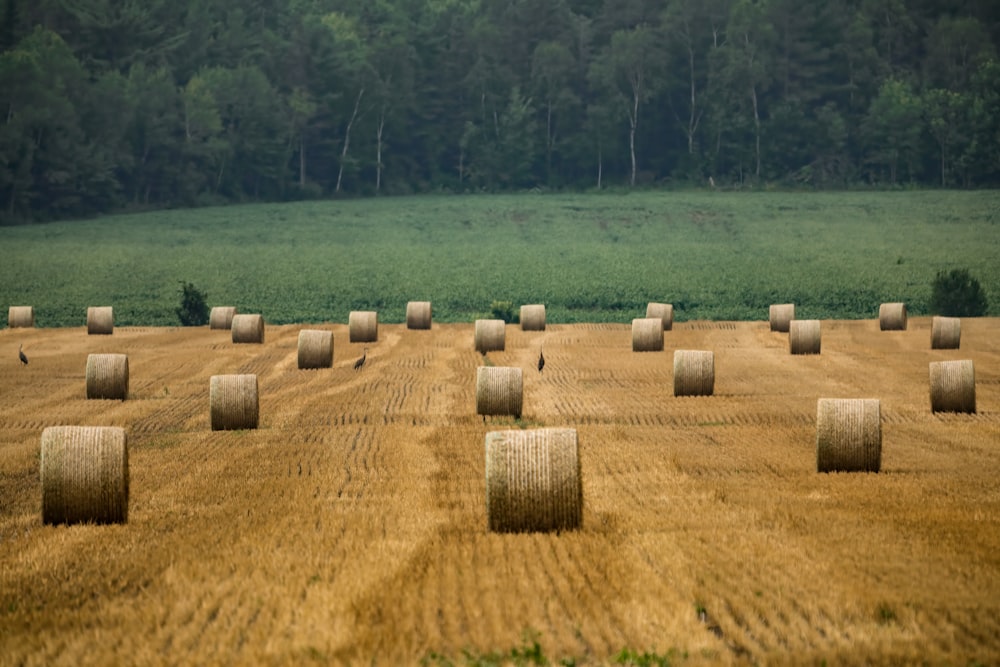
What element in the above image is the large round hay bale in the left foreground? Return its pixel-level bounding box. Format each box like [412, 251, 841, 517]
[41, 426, 128, 524]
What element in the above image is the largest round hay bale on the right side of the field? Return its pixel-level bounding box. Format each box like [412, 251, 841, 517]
[816, 398, 882, 472]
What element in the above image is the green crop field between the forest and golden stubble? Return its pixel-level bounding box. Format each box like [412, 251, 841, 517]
[0, 191, 1000, 327]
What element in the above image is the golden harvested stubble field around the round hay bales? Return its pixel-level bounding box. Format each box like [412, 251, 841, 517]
[0, 317, 1000, 665]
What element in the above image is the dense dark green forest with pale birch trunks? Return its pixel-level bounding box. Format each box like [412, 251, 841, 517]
[0, 0, 1000, 222]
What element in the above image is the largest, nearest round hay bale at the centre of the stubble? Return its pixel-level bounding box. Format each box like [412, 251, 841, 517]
[486, 428, 583, 533]
